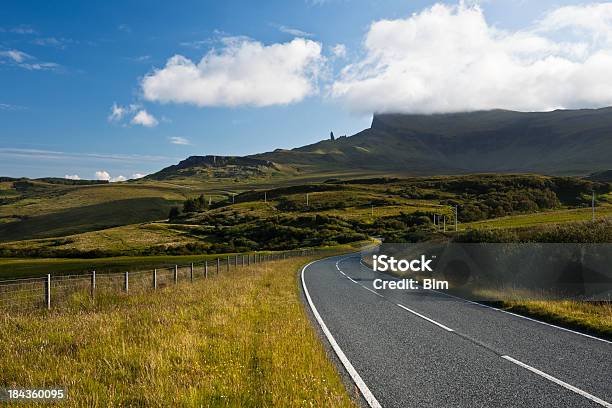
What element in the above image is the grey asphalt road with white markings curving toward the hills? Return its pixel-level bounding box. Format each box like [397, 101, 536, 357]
[301, 255, 612, 408]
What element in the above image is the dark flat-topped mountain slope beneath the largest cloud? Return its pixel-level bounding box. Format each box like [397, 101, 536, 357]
[251, 108, 612, 175]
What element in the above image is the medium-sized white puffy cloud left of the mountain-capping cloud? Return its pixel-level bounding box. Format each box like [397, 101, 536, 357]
[141, 37, 323, 106]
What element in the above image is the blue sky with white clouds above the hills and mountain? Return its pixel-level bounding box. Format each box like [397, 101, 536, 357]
[0, 0, 612, 179]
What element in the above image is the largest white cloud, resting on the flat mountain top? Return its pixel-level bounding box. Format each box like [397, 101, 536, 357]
[330, 3, 612, 113]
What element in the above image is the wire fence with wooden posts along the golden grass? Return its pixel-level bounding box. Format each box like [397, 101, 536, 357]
[0, 249, 326, 311]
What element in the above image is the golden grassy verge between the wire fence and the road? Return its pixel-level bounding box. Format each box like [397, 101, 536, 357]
[0, 258, 353, 407]
